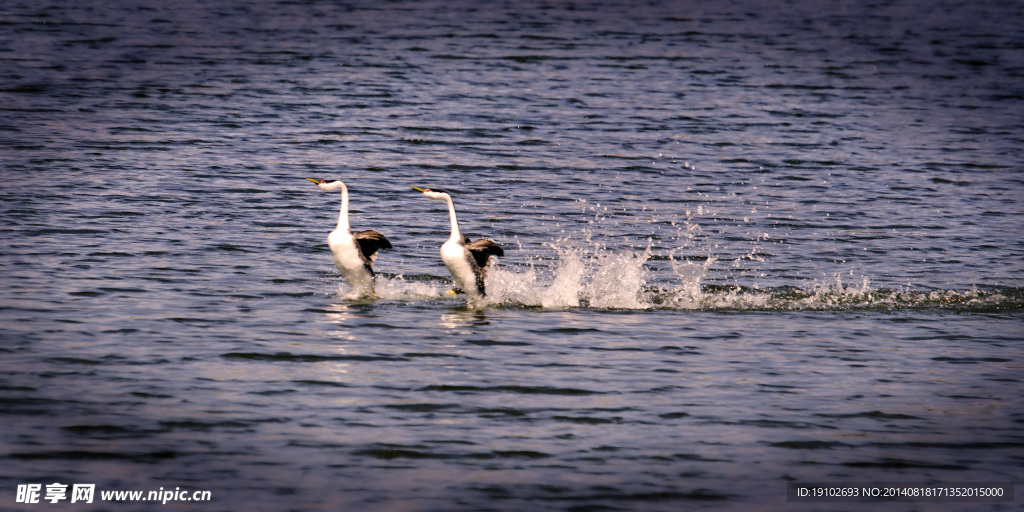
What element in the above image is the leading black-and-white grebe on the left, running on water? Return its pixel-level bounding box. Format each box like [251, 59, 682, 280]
[306, 178, 391, 297]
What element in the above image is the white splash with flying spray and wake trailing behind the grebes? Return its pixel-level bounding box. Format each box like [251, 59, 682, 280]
[348, 205, 1024, 312]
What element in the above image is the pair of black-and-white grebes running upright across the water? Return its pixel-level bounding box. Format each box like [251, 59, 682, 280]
[306, 178, 505, 300]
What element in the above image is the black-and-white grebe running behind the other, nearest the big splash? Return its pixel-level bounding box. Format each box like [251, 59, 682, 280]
[413, 186, 505, 300]
